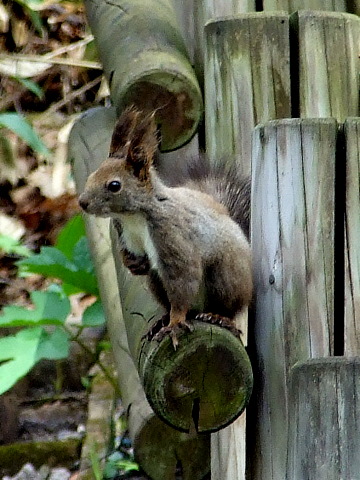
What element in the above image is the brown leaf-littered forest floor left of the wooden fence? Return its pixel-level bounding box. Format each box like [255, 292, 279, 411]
[0, 0, 146, 480]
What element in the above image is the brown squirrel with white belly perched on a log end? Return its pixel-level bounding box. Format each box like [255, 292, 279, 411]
[79, 107, 252, 348]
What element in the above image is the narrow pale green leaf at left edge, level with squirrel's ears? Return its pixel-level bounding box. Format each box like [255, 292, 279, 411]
[0, 113, 50, 156]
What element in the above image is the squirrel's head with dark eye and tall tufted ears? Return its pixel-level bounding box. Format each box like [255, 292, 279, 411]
[79, 107, 158, 217]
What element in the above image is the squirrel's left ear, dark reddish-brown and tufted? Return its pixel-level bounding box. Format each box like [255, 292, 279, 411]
[109, 106, 141, 157]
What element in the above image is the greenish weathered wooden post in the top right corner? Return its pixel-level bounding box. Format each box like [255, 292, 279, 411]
[292, 11, 360, 122]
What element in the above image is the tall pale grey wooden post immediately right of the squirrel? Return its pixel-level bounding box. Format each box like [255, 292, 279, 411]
[250, 119, 337, 480]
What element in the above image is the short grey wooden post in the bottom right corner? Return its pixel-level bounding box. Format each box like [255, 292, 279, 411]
[288, 357, 360, 480]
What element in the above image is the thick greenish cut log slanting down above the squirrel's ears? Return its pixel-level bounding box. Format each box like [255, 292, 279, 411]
[85, 0, 202, 151]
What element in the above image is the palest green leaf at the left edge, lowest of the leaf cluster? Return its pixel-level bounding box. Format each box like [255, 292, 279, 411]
[0, 327, 43, 395]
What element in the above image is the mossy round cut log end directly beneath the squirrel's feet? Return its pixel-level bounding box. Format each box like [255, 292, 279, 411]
[139, 322, 253, 433]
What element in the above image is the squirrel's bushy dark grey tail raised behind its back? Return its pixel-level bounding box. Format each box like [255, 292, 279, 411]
[160, 155, 251, 238]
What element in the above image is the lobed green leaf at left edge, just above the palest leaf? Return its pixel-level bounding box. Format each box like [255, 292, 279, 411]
[0, 291, 70, 327]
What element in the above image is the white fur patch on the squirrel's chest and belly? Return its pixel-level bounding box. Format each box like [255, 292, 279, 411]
[120, 213, 158, 269]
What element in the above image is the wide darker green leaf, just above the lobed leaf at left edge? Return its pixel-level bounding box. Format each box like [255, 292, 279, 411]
[16, 247, 98, 296]
